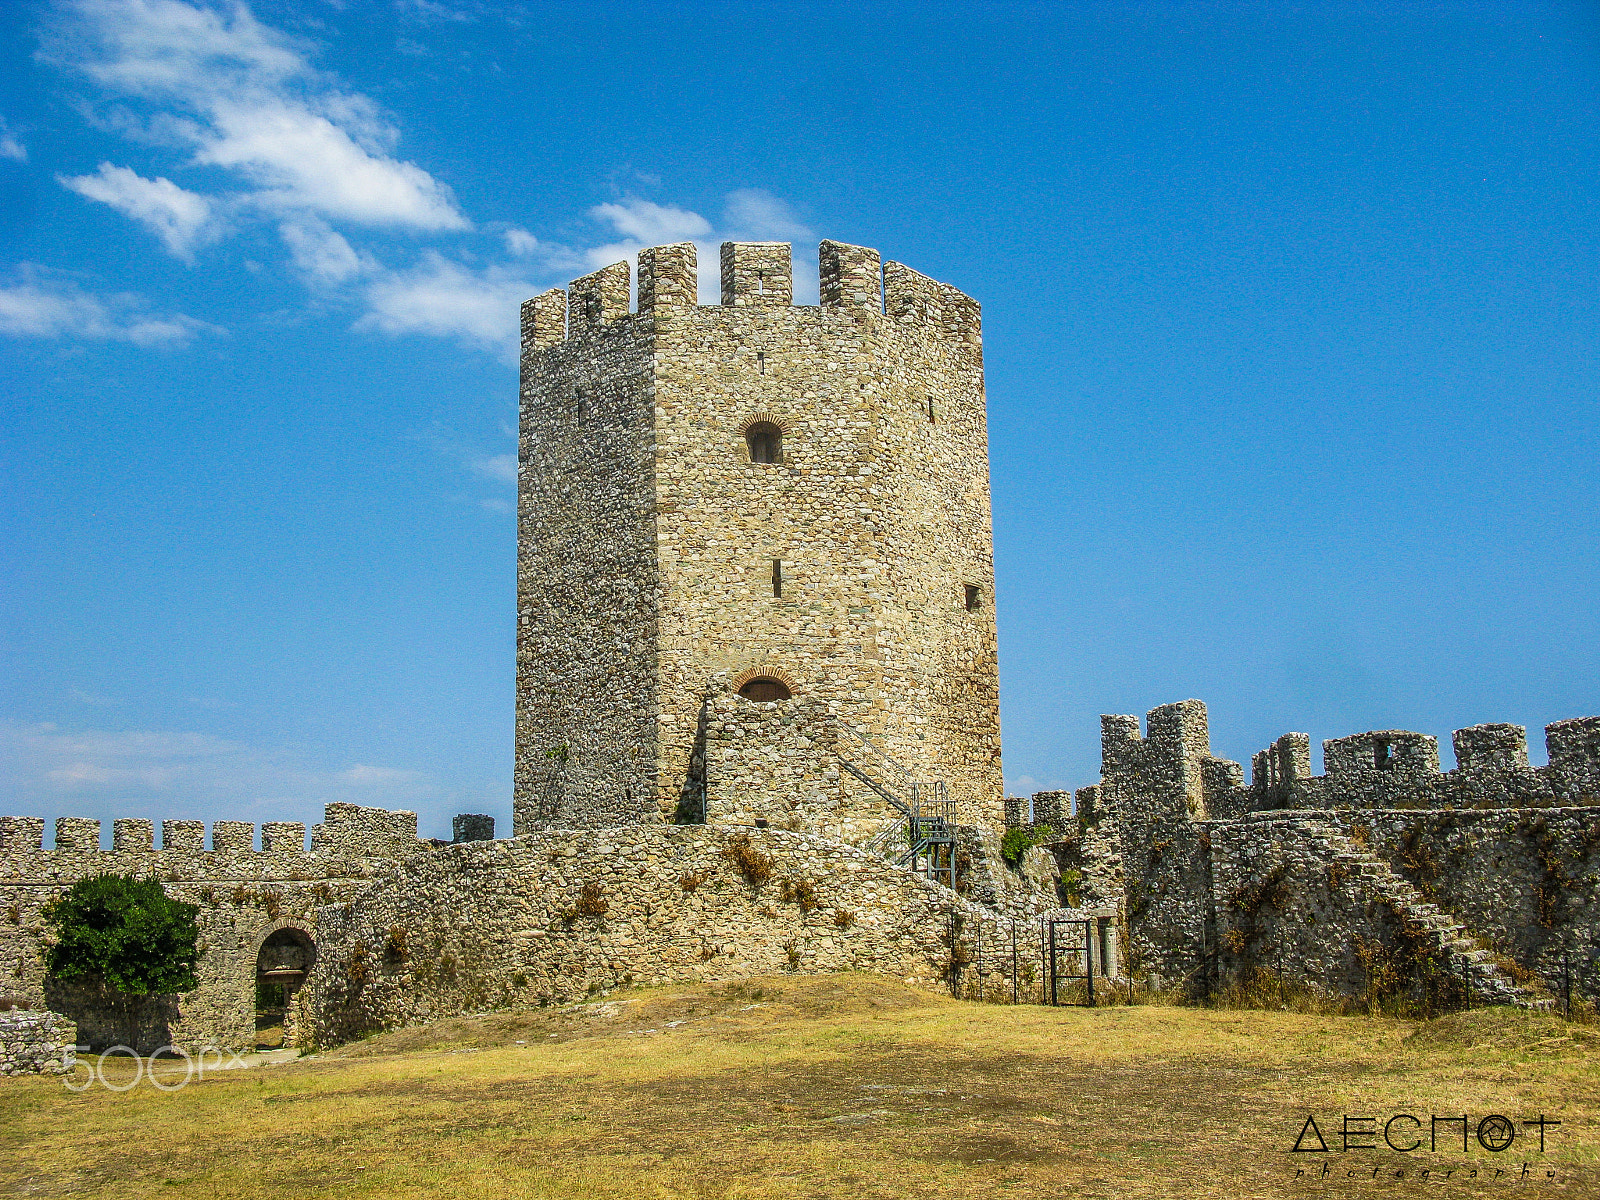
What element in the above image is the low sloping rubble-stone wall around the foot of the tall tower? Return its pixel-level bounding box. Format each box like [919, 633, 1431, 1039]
[306, 826, 1038, 1043]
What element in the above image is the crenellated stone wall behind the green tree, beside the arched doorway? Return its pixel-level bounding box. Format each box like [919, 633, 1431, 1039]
[0, 805, 429, 1050]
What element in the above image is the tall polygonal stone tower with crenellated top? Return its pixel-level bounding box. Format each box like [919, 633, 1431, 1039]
[514, 242, 1003, 840]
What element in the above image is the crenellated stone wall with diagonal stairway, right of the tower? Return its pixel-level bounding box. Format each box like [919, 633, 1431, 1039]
[1030, 701, 1600, 1006]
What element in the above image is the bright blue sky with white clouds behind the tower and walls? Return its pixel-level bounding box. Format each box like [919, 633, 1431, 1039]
[0, 0, 1600, 835]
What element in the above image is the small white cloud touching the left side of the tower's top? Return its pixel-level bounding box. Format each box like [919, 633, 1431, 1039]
[357, 251, 539, 357]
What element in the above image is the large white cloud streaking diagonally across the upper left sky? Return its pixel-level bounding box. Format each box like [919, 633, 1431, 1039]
[46, 0, 470, 232]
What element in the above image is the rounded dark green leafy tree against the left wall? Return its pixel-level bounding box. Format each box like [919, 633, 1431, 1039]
[45, 875, 200, 1045]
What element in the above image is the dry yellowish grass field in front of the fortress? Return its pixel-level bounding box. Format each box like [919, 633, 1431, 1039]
[0, 976, 1600, 1200]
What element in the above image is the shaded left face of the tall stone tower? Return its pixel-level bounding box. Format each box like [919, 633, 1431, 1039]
[512, 262, 661, 830]
